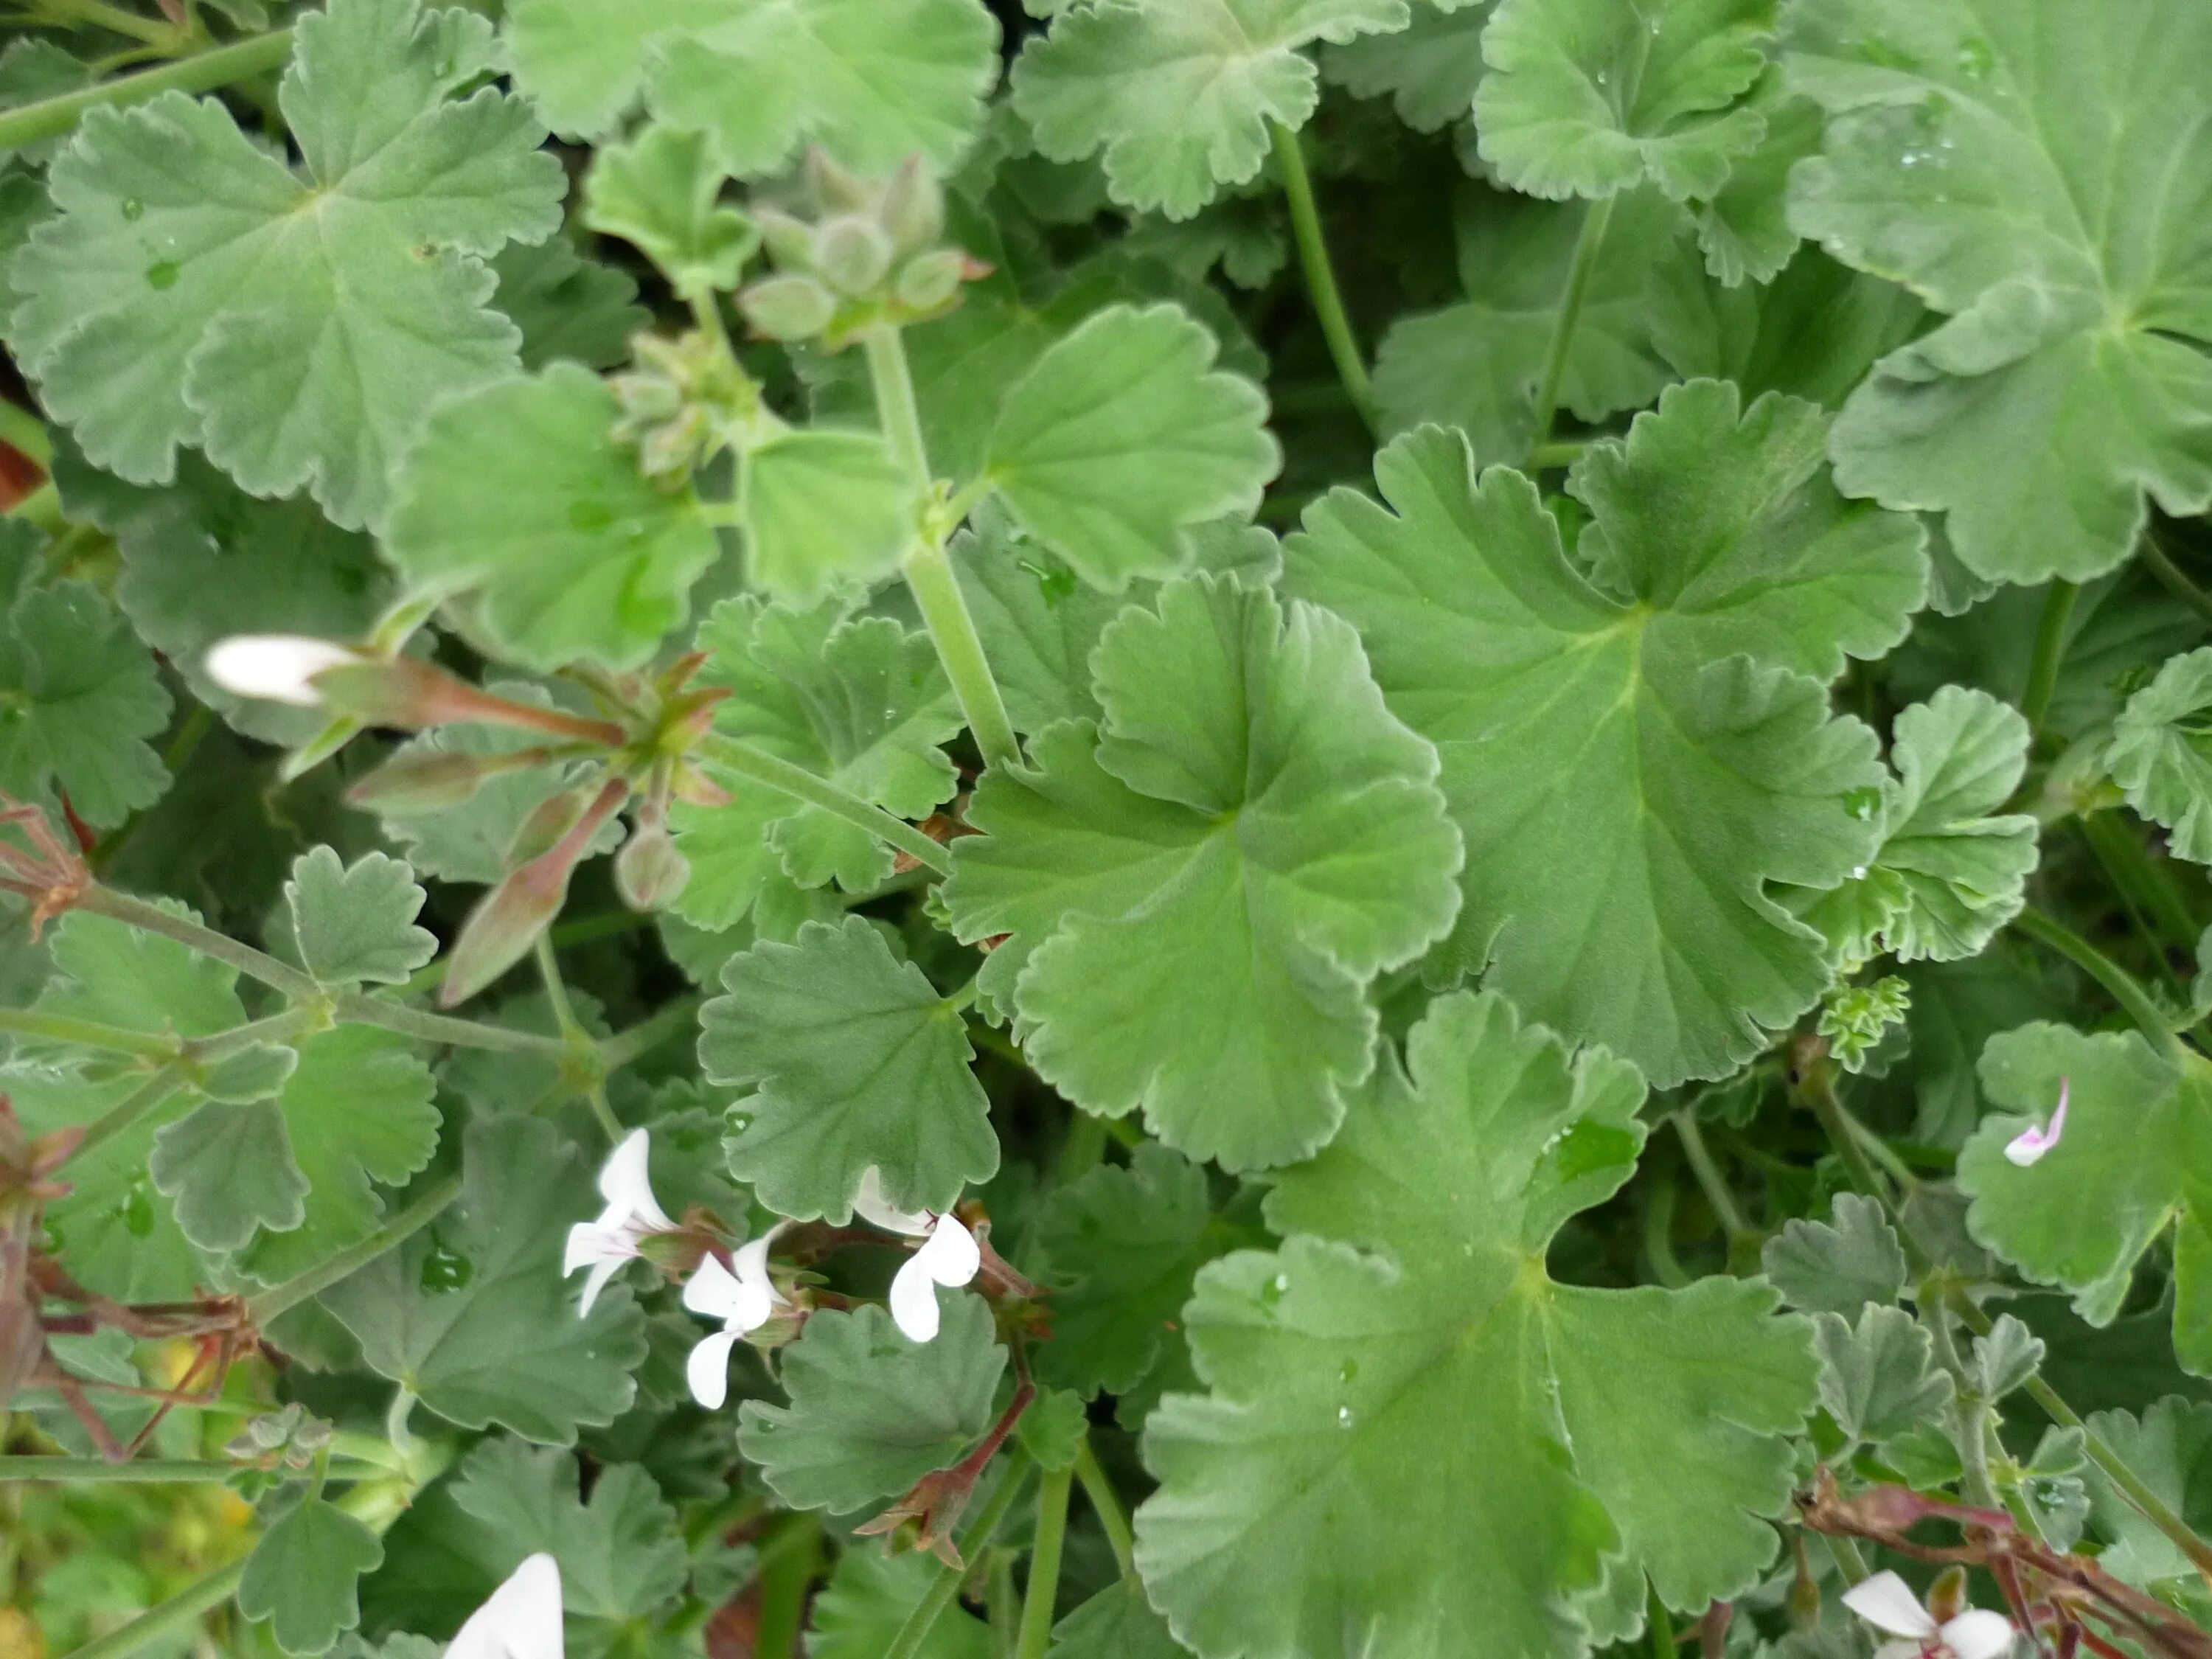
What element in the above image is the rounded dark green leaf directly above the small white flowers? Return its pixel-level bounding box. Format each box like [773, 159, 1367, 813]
[699, 916, 998, 1223]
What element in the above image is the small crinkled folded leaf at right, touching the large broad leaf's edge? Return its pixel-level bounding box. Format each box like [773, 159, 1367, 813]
[1803, 690, 2026, 967]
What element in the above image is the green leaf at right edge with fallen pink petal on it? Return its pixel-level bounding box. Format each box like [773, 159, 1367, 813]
[1958, 1024, 2212, 1376]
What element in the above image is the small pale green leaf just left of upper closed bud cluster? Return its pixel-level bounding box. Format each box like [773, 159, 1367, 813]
[584, 126, 761, 294]
